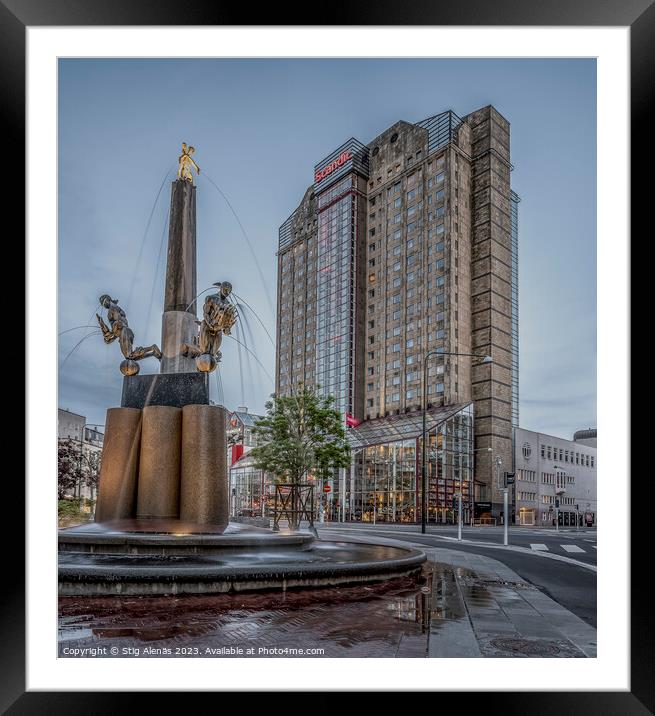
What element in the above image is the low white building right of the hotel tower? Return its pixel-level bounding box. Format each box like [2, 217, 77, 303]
[514, 428, 598, 527]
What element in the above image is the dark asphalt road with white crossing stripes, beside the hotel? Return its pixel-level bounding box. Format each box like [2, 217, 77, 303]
[318, 523, 596, 627]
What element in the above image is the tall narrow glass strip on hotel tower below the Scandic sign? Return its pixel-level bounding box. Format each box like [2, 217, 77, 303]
[315, 174, 359, 413]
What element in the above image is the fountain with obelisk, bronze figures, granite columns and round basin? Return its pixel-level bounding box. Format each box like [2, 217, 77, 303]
[59, 144, 426, 595]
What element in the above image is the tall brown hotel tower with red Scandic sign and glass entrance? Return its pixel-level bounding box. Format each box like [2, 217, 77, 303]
[276, 106, 518, 521]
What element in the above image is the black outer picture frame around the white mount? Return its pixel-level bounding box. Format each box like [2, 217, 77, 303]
[0, 0, 640, 716]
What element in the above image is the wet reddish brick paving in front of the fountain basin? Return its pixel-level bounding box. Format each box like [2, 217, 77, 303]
[59, 568, 431, 658]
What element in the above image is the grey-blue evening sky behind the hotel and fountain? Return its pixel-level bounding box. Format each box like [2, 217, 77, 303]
[57, 59, 596, 439]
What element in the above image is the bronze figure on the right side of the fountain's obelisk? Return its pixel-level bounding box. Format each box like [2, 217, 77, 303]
[182, 281, 237, 373]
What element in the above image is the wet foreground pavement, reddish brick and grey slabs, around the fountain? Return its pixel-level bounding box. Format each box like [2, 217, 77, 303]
[59, 549, 596, 658]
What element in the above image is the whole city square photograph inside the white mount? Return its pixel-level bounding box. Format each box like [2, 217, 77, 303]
[53, 58, 606, 659]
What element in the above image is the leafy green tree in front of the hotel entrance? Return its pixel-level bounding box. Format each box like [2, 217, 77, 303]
[250, 384, 350, 529]
